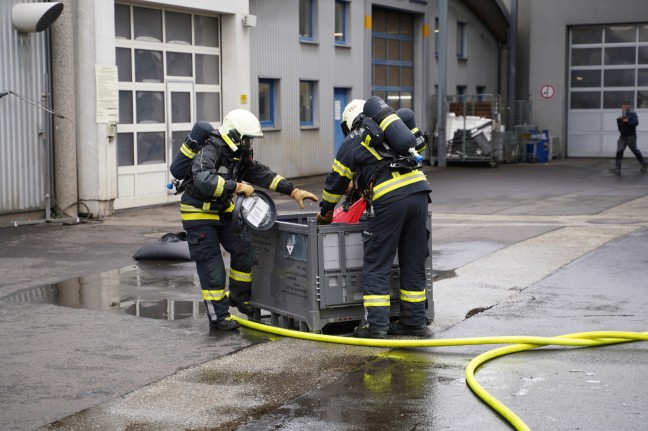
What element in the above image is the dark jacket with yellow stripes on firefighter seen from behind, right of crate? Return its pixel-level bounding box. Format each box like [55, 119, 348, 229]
[320, 123, 432, 215]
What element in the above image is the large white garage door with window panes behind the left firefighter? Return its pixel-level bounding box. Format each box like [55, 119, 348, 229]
[115, 4, 222, 209]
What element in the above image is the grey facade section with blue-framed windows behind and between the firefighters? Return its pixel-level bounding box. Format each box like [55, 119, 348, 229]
[250, 0, 508, 177]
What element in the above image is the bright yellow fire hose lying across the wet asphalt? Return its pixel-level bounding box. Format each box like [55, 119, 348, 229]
[232, 316, 648, 430]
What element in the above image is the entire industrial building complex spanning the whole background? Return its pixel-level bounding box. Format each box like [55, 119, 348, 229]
[0, 0, 648, 223]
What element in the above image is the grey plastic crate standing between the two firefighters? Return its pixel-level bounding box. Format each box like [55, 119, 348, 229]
[250, 213, 434, 332]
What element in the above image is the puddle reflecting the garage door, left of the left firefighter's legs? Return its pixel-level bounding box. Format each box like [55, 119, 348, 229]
[2, 261, 206, 320]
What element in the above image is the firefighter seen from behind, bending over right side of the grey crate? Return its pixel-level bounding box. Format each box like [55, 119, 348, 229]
[317, 101, 432, 338]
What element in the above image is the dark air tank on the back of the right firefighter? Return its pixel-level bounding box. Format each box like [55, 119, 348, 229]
[363, 96, 422, 159]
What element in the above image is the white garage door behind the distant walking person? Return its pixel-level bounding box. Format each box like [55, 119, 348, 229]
[567, 24, 648, 157]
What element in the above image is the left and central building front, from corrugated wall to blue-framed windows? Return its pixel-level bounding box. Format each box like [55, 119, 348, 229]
[0, 0, 509, 220]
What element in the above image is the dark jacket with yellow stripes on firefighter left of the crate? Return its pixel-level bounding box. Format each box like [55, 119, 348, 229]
[170, 132, 295, 228]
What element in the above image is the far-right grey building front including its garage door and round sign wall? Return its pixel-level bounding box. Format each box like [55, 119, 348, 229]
[517, 0, 648, 158]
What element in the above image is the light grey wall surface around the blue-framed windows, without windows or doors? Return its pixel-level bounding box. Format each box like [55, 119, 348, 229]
[250, 0, 502, 178]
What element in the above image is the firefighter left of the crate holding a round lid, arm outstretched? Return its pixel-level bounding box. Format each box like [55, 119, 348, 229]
[171, 109, 318, 330]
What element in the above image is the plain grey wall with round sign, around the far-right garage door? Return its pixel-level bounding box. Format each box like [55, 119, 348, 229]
[527, 0, 648, 154]
